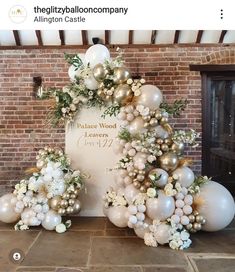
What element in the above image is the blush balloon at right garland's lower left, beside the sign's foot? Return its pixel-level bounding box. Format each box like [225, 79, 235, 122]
[108, 206, 128, 228]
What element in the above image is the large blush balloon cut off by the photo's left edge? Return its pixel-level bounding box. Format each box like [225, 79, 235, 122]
[0, 194, 20, 223]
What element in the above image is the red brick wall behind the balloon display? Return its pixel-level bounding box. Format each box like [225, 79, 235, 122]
[0, 45, 235, 195]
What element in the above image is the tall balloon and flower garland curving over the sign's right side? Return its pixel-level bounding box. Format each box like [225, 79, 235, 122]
[39, 44, 235, 249]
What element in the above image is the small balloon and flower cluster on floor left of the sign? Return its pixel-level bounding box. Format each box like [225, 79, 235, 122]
[0, 147, 84, 233]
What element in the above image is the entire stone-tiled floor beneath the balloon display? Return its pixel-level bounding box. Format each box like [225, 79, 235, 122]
[0, 217, 235, 272]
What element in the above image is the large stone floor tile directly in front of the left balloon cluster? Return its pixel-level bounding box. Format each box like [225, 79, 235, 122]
[22, 231, 90, 267]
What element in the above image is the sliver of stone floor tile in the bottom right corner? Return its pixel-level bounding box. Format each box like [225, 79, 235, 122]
[194, 258, 235, 272]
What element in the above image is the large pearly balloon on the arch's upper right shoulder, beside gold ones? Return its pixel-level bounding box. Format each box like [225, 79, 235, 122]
[136, 85, 163, 110]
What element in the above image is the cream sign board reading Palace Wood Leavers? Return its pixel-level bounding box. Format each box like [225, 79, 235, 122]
[65, 109, 120, 216]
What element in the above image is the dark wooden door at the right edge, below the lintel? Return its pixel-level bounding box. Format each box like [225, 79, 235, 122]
[202, 72, 235, 195]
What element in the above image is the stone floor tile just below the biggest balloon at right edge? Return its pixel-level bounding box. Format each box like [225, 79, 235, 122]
[185, 230, 235, 253]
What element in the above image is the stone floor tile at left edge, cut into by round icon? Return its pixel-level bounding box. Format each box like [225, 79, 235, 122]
[0, 231, 39, 272]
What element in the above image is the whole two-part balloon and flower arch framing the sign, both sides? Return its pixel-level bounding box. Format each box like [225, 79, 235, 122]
[0, 44, 235, 249]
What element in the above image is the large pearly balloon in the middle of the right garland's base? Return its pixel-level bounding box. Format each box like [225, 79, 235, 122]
[146, 190, 175, 221]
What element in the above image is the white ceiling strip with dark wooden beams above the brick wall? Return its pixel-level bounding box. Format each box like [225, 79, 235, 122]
[0, 30, 235, 49]
